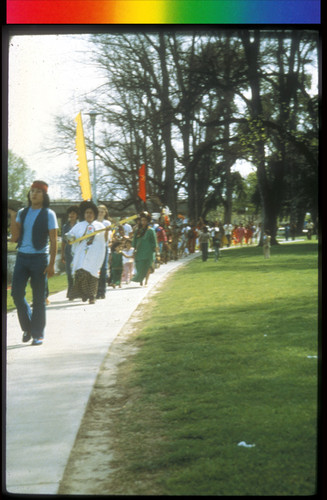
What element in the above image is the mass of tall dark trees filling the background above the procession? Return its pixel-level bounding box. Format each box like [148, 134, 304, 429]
[54, 29, 319, 240]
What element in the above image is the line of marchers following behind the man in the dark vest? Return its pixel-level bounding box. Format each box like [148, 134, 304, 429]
[61, 206, 260, 304]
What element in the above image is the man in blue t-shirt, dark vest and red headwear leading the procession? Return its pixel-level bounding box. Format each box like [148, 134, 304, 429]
[9, 181, 58, 345]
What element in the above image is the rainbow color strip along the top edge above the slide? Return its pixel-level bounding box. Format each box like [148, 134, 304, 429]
[7, 0, 321, 24]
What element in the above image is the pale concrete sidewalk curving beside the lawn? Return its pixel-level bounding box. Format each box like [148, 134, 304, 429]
[6, 253, 199, 494]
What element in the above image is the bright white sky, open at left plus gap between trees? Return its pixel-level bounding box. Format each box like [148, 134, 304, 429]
[8, 34, 320, 200]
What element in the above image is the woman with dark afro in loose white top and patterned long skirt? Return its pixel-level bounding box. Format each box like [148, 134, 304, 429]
[66, 201, 109, 304]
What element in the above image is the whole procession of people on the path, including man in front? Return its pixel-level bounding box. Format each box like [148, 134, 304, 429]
[9, 181, 270, 345]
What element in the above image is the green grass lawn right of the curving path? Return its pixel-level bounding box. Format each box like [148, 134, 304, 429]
[59, 242, 318, 496]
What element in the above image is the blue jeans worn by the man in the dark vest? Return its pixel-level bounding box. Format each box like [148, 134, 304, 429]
[11, 252, 48, 339]
